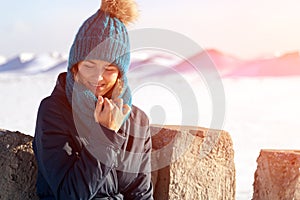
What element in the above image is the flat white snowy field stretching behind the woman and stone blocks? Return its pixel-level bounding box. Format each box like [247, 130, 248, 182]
[0, 52, 300, 200]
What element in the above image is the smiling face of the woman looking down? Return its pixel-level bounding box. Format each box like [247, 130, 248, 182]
[75, 60, 119, 97]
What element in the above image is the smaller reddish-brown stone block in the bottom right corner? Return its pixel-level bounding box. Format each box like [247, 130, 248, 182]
[253, 150, 300, 200]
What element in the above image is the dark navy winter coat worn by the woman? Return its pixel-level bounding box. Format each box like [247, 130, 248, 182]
[33, 73, 153, 200]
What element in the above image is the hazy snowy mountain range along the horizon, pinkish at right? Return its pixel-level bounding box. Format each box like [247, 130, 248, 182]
[0, 49, 300, 78]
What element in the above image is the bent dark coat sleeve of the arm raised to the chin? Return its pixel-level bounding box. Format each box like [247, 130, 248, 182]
[34, 99, 123, 199]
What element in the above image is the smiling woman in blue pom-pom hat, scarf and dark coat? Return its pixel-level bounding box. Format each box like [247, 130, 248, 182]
[33, 0, 153, 200]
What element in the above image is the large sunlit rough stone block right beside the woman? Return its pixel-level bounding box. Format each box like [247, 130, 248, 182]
[151, 126, 236, 200]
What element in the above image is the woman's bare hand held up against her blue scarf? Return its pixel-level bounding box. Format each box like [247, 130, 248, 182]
[94, 96, 131, 132]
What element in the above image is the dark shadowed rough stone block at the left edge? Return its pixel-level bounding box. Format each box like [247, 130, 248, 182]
[0, 130, 38, 200]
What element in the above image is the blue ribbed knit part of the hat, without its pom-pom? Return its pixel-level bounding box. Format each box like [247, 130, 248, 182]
[68, 9, 130, 75]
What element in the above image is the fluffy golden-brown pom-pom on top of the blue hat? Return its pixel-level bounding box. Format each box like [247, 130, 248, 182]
[100, 0, 138, 25]
